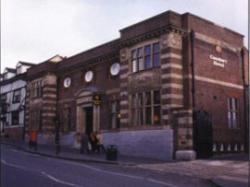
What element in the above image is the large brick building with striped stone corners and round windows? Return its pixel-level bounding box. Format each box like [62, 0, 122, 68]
[26, 11, 249, 159]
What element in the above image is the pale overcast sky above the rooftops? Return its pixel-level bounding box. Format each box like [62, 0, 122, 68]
[1, 0, 248, 71]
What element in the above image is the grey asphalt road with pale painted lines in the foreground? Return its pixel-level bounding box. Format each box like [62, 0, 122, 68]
[1, 145, 216, 187]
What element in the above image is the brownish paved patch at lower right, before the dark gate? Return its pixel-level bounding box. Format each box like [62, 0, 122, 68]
[136, 154, 249, 187]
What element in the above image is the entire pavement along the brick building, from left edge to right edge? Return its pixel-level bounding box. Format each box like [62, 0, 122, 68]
[1, 140, 249, 187]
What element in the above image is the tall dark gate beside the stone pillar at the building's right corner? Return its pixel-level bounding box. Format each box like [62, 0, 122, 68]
[194, 111, 213, 158]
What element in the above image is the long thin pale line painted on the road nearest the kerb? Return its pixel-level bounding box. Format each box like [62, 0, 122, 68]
[57, 160, 178, 187]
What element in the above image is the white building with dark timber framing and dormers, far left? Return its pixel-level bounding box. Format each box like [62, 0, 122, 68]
[0, 62, 34, 139]
